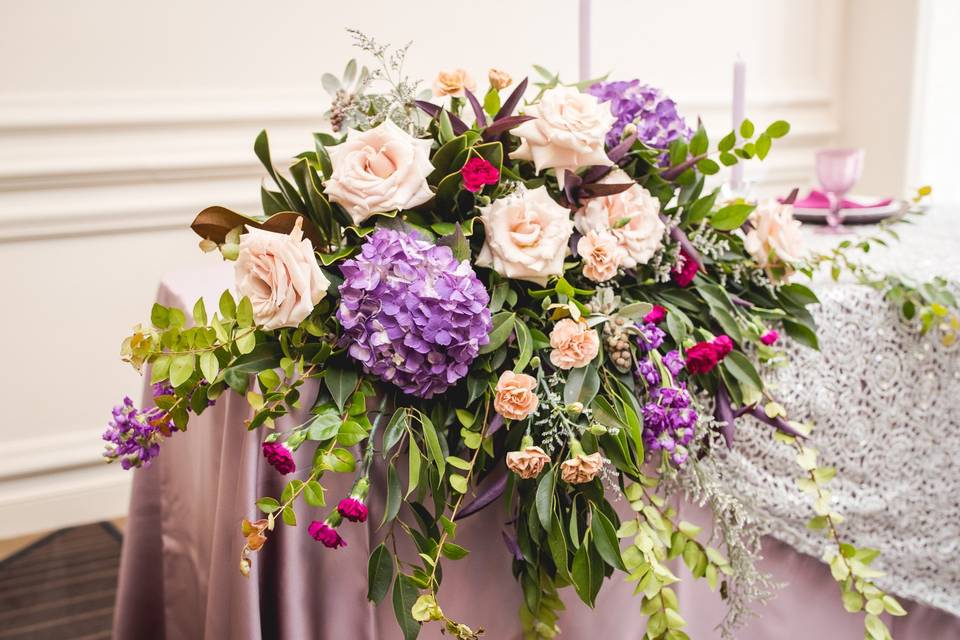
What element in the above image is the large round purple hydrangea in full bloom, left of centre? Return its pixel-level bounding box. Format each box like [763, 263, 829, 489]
[337, 229, 493, 398]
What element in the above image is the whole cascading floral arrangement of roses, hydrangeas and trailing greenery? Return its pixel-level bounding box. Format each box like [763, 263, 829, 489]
[104, 34, 928, 639]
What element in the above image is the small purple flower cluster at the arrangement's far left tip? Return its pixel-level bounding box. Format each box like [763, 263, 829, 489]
[103, 390, 172, 469]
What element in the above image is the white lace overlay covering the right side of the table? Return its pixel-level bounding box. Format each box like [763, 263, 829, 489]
[730, 211, 960, 615]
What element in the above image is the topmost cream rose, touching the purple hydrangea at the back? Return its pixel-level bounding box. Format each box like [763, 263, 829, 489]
[510, 87, 615, 186]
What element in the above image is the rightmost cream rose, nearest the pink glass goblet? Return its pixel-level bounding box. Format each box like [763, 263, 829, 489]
[743, 200, 806, 267]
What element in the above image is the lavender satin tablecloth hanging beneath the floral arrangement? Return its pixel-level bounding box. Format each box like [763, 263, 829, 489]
[114, 265, 960, 640]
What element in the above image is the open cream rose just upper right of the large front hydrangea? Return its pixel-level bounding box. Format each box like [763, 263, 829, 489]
[477, 187, 573, 285]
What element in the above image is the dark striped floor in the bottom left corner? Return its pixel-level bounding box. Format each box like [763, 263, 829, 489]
[0, 522, 121, 640]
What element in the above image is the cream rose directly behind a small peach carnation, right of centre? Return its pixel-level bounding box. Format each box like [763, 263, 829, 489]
[574, 169, 666, 268]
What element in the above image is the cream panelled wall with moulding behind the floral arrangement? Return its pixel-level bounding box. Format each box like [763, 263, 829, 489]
[0, 0, 916, 537]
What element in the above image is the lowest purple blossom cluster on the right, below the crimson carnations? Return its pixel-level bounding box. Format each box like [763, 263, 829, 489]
[643, 386, 699, 466]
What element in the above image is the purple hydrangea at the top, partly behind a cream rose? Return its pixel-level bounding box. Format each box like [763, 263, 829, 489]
[587, 80, 693, 149]
